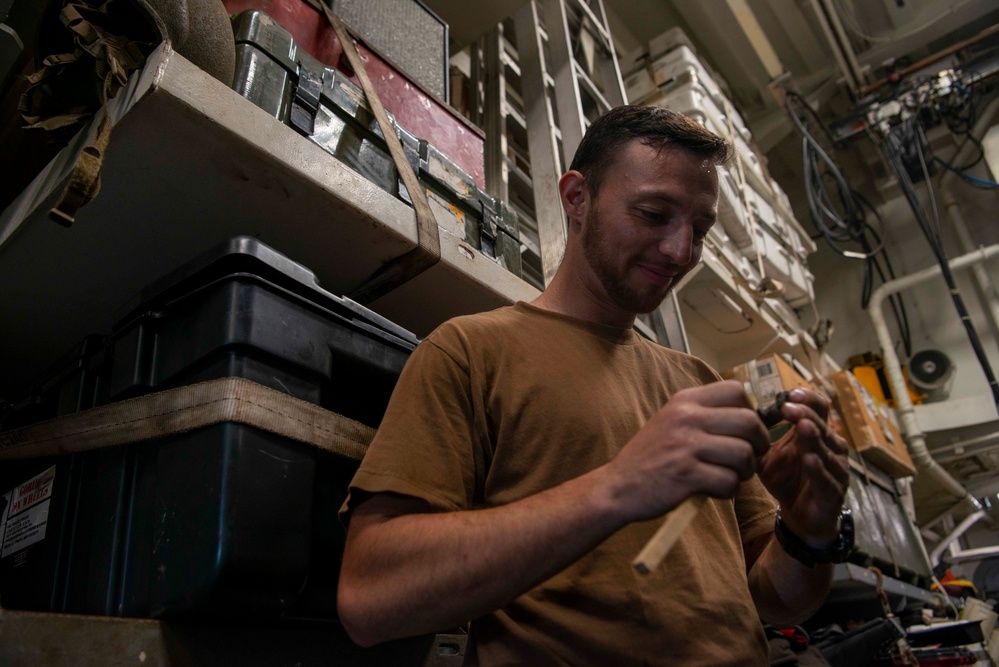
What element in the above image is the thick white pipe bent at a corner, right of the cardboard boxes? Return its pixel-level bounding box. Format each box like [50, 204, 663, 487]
[868, 244, 999, 510]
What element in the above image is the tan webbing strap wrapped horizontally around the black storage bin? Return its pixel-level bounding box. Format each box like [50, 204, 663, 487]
[0, 378, 375, 461]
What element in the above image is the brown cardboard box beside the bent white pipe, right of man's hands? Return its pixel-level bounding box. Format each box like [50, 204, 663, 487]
[832, 371, 916, 478]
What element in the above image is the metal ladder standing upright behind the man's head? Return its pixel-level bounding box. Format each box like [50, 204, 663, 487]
[472, 0, 625, 287]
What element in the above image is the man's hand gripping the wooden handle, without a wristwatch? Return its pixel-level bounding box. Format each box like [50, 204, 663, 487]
[605, 381, 770, 521]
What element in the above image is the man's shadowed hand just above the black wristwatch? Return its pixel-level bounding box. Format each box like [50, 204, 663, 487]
[758, 389, 850, 548]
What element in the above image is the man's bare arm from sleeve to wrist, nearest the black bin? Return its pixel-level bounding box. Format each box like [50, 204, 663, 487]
[338, 470, 627, 645]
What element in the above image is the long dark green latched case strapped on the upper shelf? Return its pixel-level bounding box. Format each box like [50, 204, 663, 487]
[233, 11, 522, 276]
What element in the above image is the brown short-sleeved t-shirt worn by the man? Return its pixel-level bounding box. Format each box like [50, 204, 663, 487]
[343, 303, 774, 667]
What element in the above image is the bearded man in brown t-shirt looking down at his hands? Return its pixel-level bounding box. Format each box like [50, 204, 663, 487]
[338, 107, 848, 666]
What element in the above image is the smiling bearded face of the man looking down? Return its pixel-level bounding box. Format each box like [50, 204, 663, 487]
[581, 141, 718, 313]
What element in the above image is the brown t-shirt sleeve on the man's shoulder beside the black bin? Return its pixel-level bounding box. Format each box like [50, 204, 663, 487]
[340, 330, 475, 524]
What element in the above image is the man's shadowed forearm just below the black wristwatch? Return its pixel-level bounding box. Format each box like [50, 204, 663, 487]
[749, 538, 834, 627]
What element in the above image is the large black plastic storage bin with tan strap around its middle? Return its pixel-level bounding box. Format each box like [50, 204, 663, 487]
[0, 237, 417, 618]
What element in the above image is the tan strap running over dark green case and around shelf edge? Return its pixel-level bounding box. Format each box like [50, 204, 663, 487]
[318, 0, 441, 304]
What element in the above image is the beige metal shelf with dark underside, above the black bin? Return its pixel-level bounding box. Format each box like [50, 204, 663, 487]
[0, 46, 537, 398]
